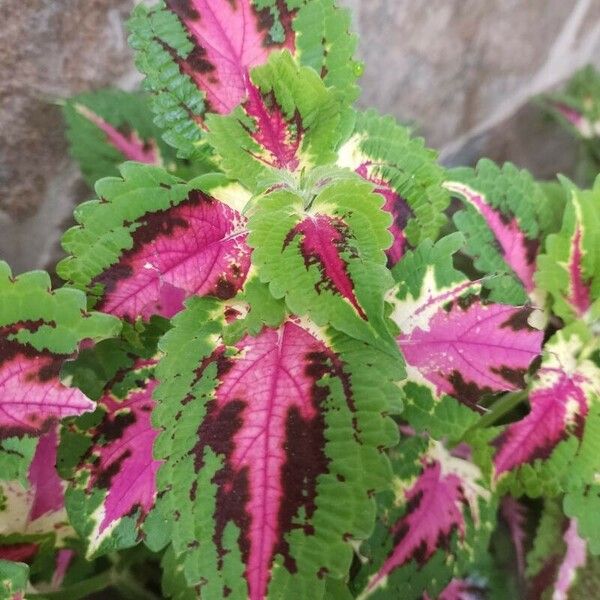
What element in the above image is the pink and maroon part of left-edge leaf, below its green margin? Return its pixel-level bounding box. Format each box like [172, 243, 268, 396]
[0, 342, 94, 436]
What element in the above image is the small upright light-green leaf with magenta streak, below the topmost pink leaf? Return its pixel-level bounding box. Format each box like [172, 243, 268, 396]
[207, 52, 351, 192]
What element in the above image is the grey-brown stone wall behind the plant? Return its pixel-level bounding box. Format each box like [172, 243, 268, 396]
[0, 0, 600, 272]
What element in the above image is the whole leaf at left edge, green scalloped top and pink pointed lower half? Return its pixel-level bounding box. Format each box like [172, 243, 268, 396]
[0, 262, 120, 437]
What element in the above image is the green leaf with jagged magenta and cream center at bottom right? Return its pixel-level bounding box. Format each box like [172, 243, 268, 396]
[355, 437, 496, 600]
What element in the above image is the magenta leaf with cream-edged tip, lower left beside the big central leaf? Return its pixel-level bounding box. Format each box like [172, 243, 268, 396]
[64, 359, 160, 555]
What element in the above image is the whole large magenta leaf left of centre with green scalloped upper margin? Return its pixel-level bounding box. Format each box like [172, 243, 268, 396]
[58, 163, 250, 321]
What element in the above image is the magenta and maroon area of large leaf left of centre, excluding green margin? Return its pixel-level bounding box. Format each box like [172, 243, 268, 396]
[96, 191, 250, 320]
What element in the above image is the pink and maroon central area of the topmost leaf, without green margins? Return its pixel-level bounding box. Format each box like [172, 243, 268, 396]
[167, 0, 294, 114]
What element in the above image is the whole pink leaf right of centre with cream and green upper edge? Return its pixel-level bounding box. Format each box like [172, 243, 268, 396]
[387, 234, 543, 408]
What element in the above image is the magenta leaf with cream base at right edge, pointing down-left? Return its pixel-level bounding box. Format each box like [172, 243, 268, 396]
[494, 330, 600, 476]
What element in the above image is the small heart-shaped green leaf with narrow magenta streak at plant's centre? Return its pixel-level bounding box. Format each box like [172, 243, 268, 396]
[248, 179, 392, 339]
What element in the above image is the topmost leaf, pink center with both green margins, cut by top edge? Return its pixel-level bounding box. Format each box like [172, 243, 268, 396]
[129, 0, 358, 156]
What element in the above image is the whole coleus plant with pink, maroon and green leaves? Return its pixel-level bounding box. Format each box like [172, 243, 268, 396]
[0, 0, 600, 600]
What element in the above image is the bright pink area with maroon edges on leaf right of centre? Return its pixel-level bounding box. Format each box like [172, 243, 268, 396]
[397, 300, 543, 406]
